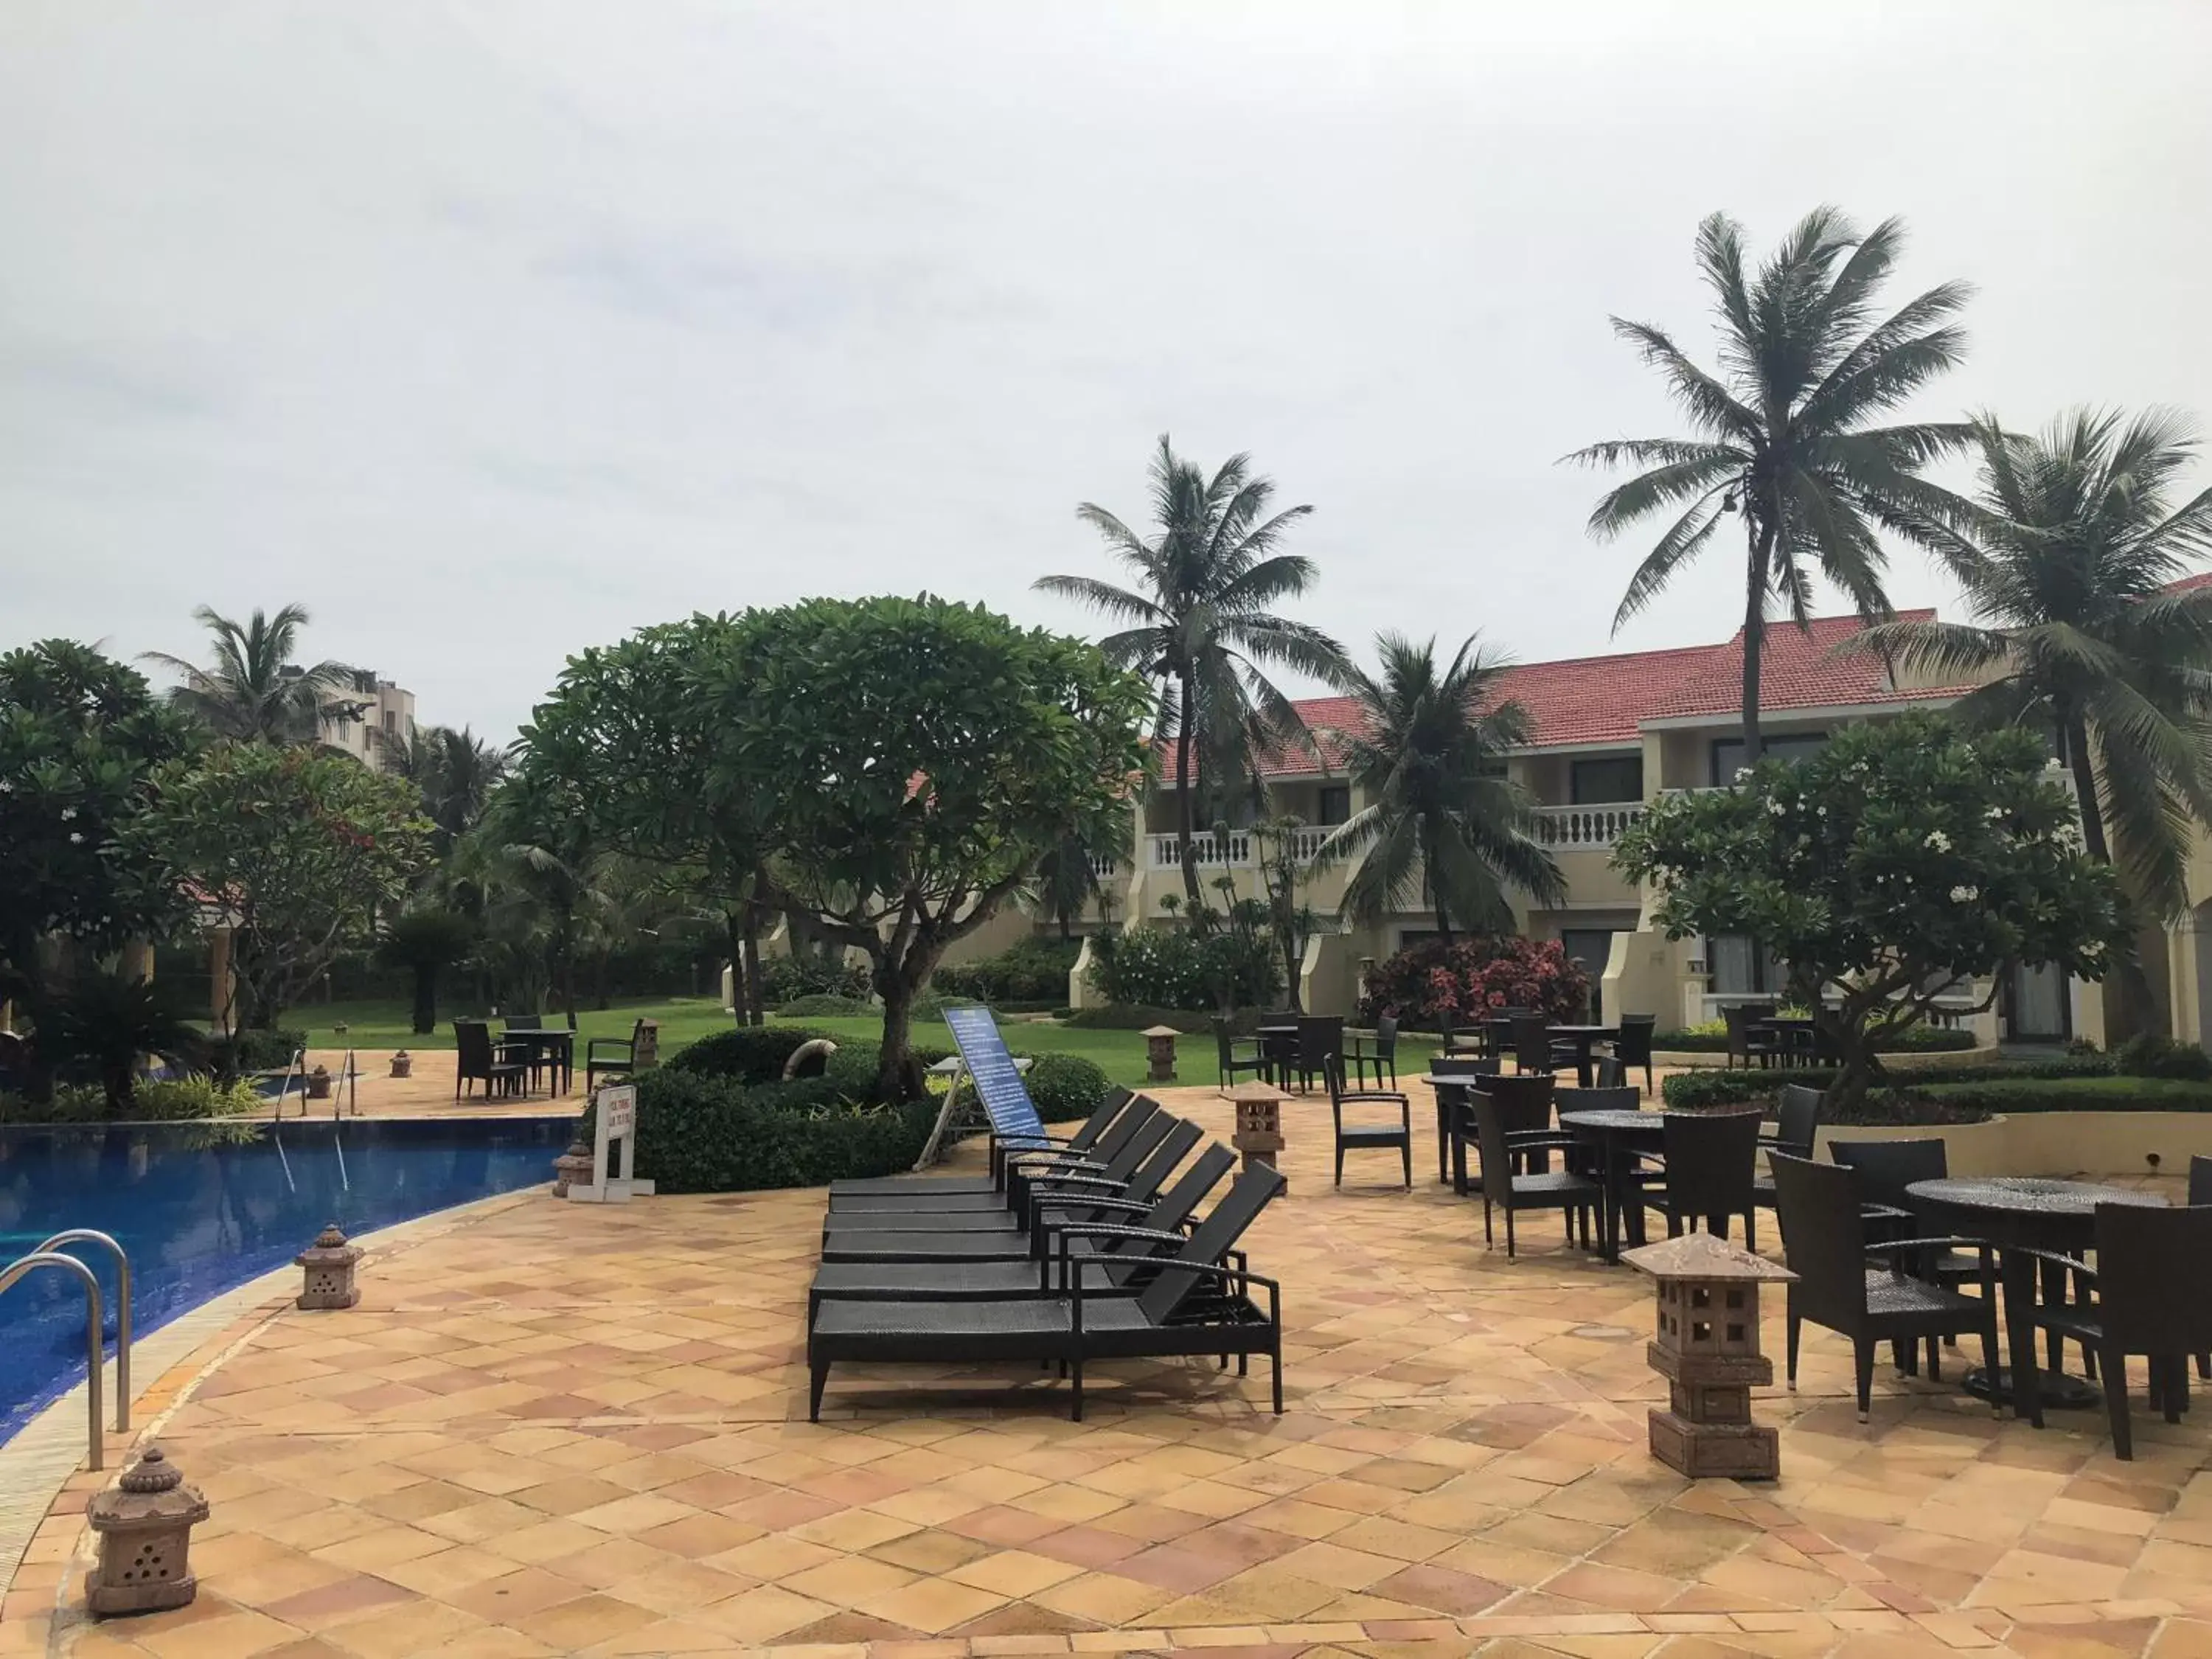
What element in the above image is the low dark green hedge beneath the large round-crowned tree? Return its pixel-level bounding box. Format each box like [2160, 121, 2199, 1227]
[577, 1079, 938, 1192]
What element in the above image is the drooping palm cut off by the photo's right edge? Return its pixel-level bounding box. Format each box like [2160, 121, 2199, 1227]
[1854, 409, 2212, 916]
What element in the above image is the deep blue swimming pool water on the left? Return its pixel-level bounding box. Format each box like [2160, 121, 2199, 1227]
[0, 1117, 575, 1442]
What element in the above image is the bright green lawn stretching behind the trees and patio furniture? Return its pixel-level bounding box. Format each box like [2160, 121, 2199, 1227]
[283, 998, 1431, 1088]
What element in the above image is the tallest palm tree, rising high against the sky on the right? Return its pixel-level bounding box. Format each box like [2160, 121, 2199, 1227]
[1568, 208, 1971, 765]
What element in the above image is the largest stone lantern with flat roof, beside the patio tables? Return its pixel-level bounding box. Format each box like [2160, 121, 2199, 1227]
[1621, 1232, 1796, 1480]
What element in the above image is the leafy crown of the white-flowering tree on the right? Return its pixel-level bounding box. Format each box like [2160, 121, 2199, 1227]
[1613, 714, 2121, 1093]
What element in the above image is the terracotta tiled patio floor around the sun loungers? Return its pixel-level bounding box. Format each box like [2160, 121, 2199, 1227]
[0, 1091, 2212, 1659]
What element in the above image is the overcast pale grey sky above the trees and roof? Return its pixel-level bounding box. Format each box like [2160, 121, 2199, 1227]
[0, 0, 2212, 737]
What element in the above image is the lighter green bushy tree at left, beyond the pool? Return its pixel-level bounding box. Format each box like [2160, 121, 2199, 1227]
[126, 743, 429, 1026]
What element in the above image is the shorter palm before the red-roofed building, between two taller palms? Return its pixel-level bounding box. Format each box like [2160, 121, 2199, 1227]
[1321, 633, 1566, 942]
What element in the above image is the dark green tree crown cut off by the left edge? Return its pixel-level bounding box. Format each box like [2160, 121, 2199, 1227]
[0, 639, 195, 1000]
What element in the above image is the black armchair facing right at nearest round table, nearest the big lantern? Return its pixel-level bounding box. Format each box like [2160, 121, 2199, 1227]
[1774, 1152, 1997, 1422]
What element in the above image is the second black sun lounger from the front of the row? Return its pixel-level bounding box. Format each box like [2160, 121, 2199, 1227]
[807, 1146, 1259, 1327]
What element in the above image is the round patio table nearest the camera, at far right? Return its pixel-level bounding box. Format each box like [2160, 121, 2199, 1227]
[1905, 1175, 2166, 1411]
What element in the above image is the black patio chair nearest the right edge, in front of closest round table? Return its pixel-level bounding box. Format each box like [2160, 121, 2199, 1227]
[2013, 1203, 2212, 1462]
